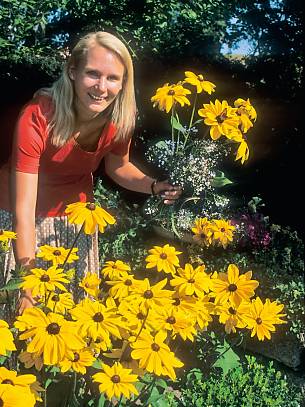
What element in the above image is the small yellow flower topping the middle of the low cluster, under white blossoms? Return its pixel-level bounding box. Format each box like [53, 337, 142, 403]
[145, 244, 182, 275]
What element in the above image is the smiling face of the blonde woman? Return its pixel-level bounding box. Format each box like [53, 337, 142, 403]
[69, 45, 125, 120]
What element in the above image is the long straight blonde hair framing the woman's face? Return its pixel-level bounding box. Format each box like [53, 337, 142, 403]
[35, 31, 136, 146]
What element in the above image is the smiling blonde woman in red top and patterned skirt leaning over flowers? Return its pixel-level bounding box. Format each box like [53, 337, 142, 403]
[0, 32, 180, 312]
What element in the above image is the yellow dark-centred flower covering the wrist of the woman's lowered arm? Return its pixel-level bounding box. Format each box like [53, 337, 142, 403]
[20, 266, 70, 297]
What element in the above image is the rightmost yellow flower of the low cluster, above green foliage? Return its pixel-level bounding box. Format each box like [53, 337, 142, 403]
[244, 297, 286, 341]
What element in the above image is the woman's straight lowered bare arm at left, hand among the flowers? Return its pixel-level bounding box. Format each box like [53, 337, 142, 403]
[11, 171, 38, 313]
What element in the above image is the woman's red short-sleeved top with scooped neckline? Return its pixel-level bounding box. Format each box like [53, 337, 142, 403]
[0, 96, 130, 217]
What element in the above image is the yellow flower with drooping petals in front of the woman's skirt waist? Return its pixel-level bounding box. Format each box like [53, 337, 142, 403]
[66, 202, 116, 235]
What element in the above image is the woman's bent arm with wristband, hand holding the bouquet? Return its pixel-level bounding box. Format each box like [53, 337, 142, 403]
[105, 153, 181, 204]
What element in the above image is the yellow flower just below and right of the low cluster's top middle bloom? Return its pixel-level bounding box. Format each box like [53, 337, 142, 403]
[170, 263, 210, 297]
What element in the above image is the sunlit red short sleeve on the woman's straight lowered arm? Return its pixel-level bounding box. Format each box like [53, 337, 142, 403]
[12, 103, 47, 174]
